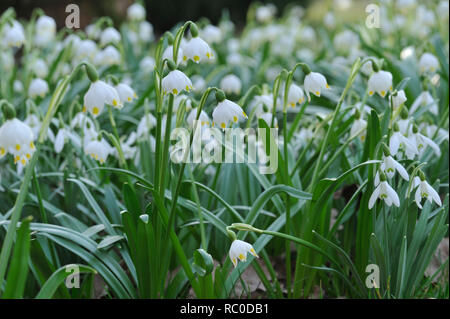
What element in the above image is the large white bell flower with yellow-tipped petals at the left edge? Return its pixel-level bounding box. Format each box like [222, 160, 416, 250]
[0, 118, 36, 166]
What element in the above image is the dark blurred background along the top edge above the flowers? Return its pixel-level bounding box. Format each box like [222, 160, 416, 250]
[0, 0, 311, 33]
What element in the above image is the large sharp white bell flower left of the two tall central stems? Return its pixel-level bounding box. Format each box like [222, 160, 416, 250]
[83, 80, 122, 117]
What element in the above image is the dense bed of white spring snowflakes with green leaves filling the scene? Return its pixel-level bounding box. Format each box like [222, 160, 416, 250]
[0, 0, 449, 298]
